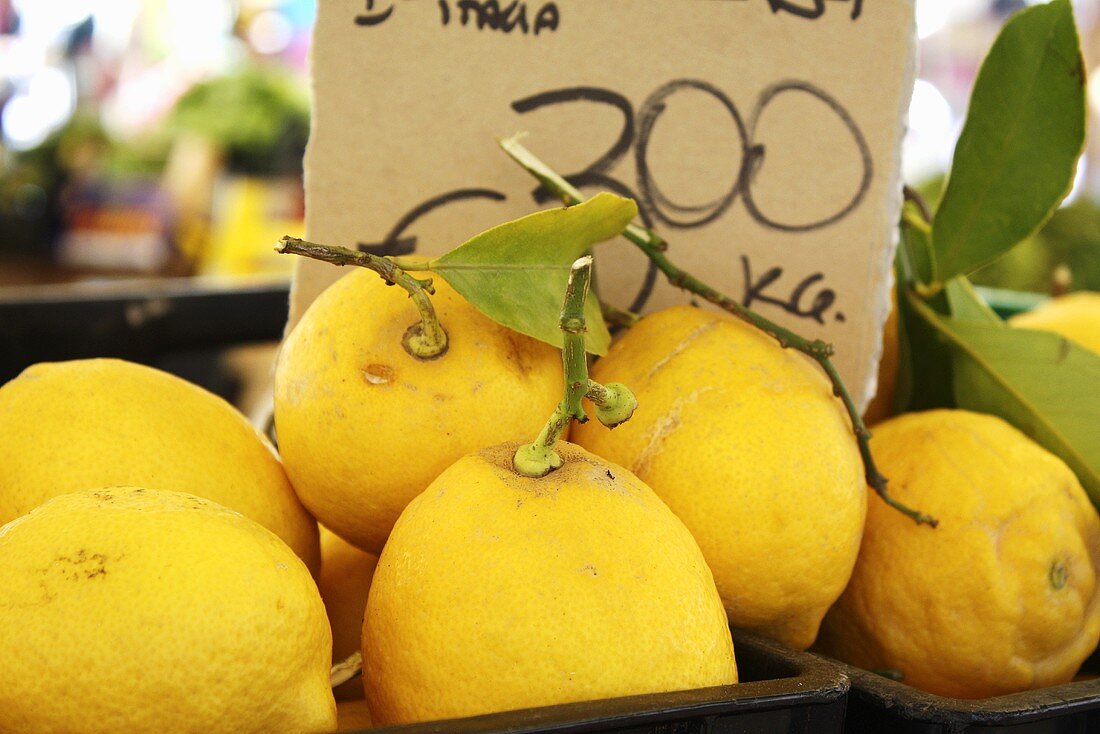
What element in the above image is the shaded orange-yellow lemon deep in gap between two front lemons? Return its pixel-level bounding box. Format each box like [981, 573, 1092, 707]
[317, 526, 378, 701]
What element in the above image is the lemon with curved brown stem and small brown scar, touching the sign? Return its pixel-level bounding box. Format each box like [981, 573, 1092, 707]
[275, 270, 562, 554]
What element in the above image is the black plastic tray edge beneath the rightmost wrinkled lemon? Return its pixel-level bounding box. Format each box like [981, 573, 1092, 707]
[836, 654, 1100, 734]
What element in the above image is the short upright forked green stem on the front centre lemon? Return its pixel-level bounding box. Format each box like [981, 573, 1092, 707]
[512, 255, 638, 478]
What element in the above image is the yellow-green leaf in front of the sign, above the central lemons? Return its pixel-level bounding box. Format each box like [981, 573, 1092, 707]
[428, 194, 638, 354]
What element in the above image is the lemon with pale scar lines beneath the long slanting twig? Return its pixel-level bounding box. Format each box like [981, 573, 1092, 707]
[573, 306, 867, 648]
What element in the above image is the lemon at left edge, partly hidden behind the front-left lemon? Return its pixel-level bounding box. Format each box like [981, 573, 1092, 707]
[0, 359, 320, 570]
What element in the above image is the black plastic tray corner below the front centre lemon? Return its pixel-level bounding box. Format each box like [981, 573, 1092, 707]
[363, 632, 848, 734]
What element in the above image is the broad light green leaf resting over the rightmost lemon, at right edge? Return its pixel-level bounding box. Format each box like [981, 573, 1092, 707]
[915, 304, 1100, 506]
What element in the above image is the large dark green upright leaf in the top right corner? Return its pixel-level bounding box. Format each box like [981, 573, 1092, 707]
[932, 0, 1085, 283]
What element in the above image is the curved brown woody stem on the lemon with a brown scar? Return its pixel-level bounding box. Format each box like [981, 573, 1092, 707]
[275, 237, 447, 360]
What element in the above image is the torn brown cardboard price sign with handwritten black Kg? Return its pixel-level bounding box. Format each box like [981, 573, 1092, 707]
[292, 0, 915, 403]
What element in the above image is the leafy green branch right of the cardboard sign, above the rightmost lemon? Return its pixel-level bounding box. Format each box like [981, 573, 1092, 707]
[895, 0, 1100, 506]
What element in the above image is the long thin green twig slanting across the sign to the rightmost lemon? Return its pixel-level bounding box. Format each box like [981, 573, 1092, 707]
[498, 138, 937, 527]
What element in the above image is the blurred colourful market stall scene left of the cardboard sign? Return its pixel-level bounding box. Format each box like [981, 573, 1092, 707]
[0, 0, 314, 284]
